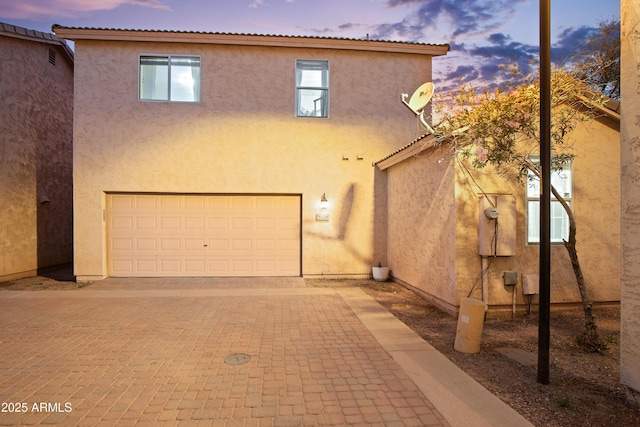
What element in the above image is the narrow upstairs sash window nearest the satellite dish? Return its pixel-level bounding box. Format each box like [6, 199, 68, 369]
[296, 59, 329, 117]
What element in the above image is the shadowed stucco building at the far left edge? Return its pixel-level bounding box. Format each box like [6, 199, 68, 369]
[0, 23, 73, 281]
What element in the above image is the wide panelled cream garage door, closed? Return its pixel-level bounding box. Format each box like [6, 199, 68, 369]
[107, 194, 301, 277]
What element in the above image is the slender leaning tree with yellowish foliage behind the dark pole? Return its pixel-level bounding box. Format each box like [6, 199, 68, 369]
[435, 64, 606, 348]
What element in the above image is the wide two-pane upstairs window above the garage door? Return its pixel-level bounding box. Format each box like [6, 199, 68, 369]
[138, 55, 200, 102]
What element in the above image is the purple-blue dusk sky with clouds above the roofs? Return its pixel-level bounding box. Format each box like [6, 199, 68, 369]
[0, 0, 620, 90]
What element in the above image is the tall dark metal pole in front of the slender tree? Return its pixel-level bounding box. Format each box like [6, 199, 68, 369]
[537, 0, 551, 384]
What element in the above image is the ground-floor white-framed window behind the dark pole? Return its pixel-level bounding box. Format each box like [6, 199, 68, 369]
[527, 158, 573, 244]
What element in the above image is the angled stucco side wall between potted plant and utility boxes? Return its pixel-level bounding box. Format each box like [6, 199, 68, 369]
[386, 142, 459, 310]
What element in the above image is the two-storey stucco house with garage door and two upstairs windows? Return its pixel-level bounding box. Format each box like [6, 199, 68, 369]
[53, 26, 449, 281]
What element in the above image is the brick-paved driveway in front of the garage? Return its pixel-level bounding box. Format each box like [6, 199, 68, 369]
[0, 279, 447, 426]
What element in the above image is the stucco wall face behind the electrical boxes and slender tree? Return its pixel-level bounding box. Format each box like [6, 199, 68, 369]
[456, 117, 620, 311]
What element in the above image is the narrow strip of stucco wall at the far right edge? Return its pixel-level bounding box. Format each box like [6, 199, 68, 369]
[620, 0, 640, 405]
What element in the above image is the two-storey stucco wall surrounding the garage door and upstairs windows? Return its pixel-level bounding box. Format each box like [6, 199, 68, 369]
[74, 40, 438, 280]
